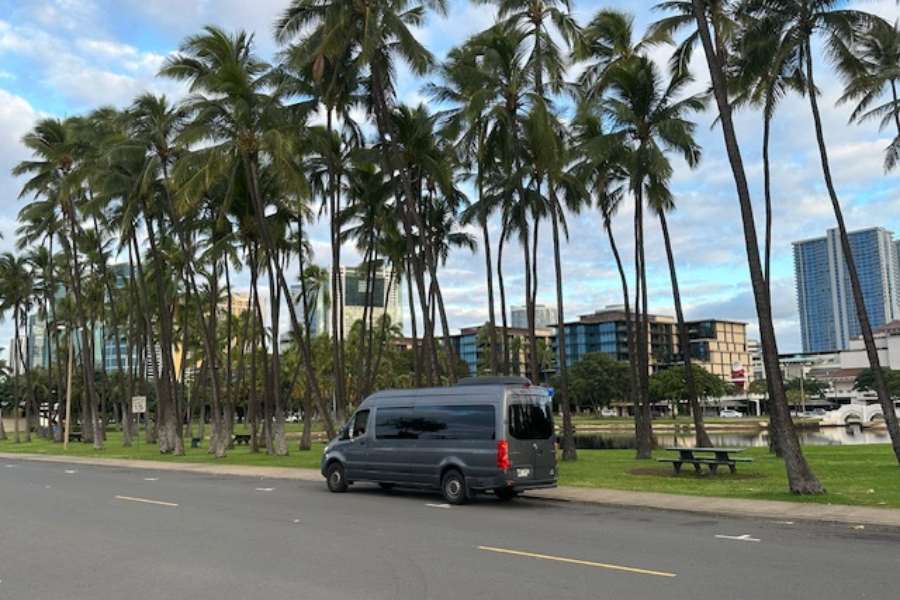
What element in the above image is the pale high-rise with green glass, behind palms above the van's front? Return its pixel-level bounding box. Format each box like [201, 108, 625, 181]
[291, 267, 403, 335]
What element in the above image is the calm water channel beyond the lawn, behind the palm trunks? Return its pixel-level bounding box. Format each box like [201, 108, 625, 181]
[575, 425, 890, 450]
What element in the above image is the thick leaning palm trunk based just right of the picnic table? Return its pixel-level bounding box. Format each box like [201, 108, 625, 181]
[691, 0, 824, 494]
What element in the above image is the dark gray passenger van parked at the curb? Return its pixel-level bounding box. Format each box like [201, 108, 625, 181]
[322, 377, 557, 504]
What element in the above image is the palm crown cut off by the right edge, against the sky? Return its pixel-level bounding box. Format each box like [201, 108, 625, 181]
[838, 20, 900, 171]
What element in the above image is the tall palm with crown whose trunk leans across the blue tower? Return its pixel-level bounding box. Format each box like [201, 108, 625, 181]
[744, 0, 900, 463]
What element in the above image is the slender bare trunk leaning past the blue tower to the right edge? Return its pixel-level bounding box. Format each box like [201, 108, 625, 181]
[806, 40, 900, 463]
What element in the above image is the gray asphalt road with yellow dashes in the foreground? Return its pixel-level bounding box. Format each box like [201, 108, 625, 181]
[0, 461, 900, 600]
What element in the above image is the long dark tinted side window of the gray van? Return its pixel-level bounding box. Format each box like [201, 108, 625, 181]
[375, 405, 495, 440]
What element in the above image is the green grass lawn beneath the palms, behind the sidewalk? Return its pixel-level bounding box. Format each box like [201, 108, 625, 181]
[0, 433, 900, 508]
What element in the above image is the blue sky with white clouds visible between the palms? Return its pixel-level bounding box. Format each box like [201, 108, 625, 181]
[0, 0, 900, 351]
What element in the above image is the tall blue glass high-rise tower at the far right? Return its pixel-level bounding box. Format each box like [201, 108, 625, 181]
[794, 227, 900, 352]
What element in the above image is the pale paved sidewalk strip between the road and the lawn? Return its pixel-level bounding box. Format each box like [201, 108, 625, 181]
[0, 453, 900, 527]
